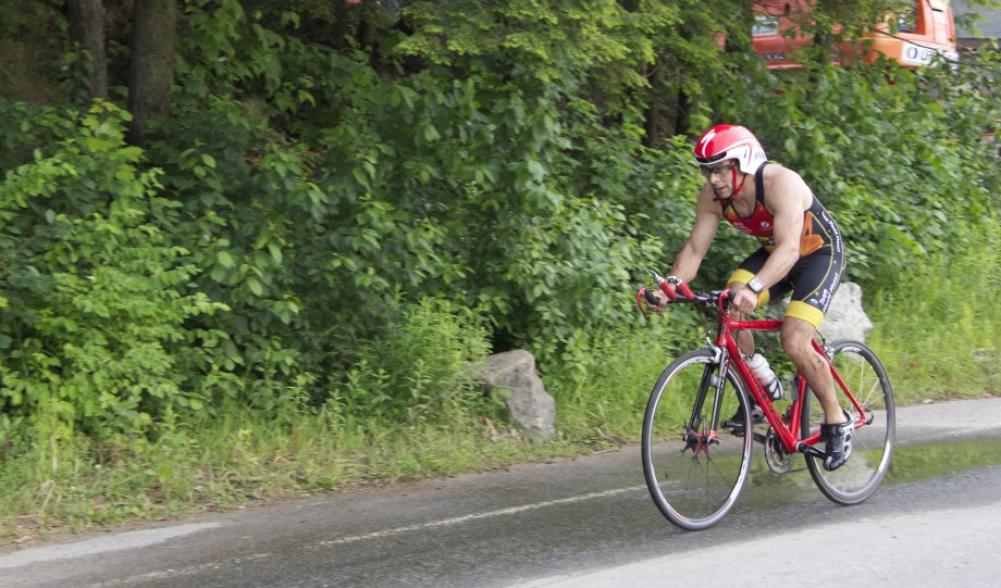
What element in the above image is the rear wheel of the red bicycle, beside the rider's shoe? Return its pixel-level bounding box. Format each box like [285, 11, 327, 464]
[801, 340, 896, 506]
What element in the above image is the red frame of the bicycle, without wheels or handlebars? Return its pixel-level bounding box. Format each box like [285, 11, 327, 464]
[695, 295, 871, 456]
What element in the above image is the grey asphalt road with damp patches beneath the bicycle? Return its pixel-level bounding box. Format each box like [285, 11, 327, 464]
[0, 399, 1001, 587]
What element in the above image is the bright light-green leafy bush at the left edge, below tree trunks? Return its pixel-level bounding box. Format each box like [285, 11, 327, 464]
[0, 103, 224, 438]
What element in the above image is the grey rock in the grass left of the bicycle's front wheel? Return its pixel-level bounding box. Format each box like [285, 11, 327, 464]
[481, 350, 557, 440]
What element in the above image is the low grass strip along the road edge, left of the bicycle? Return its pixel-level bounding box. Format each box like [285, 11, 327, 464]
[0, 412, 582, 543]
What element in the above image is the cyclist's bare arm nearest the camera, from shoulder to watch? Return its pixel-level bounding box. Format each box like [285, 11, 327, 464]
[758, 168, 813, 288]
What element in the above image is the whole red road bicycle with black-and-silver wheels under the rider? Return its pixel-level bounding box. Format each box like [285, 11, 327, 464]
[637, 272, 894, 531]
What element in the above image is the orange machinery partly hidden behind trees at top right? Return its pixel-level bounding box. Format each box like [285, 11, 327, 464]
[752, 0, 958, 69]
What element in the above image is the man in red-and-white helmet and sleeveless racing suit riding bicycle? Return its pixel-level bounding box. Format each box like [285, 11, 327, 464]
[654, 124, 853, 470]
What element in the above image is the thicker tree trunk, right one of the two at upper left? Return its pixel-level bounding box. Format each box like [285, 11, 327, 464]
[128, 0, 177, 144]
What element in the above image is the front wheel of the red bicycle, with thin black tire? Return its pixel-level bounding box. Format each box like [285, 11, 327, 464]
[642, 349, 753, 531]
